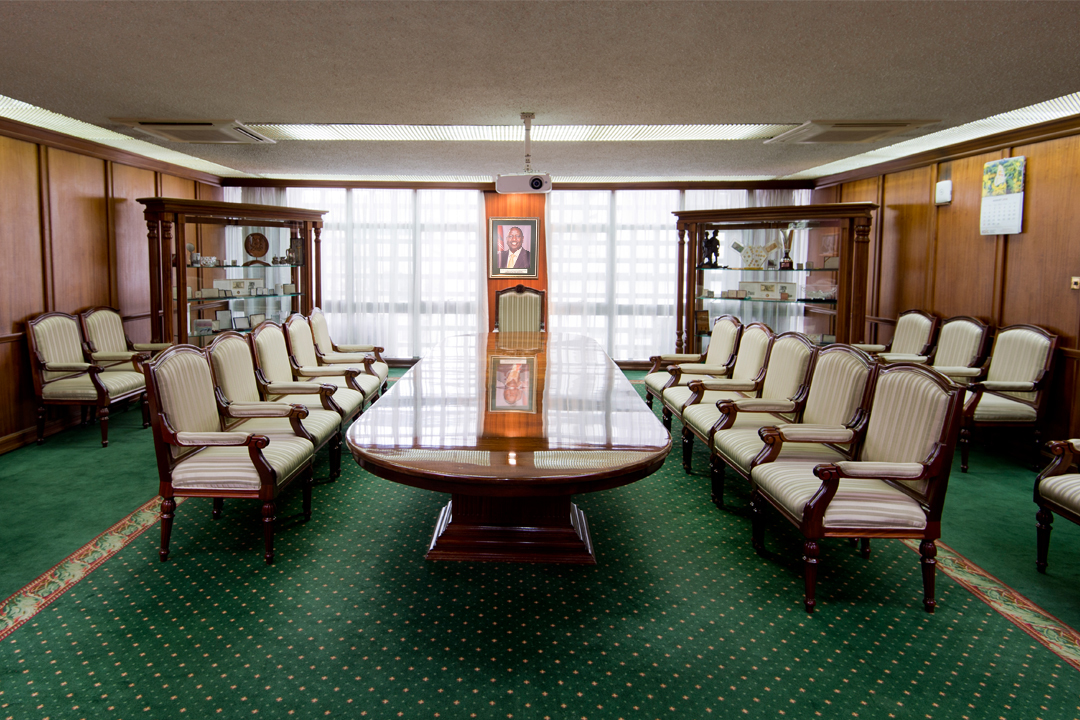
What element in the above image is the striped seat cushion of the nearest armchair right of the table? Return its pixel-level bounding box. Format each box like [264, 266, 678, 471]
[751, 462, 927, 530]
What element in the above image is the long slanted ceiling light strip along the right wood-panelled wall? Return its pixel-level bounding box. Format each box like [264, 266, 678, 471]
[784, 93, 1080, 180]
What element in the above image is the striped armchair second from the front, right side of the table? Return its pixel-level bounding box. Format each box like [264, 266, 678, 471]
[708, 343, 877, 507]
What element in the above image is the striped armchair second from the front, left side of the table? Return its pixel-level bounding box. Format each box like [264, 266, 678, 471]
[206, 330, 341, 479]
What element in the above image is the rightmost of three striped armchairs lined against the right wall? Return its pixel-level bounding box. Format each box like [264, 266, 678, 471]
[960, 325, 1057, 473]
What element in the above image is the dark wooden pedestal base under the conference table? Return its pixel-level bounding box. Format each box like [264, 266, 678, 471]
[424, 493, 596, 565]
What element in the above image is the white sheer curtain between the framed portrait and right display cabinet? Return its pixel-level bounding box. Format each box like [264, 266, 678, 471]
[546, 190, 679, 359]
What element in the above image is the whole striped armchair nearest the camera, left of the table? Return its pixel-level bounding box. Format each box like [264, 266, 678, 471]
[143, 345, 314, 565]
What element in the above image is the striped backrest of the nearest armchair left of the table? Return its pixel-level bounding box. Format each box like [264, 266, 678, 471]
[143, 345, 221, 458]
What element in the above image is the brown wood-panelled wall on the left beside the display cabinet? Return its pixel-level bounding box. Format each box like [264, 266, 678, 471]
[0, 125, 224, 452]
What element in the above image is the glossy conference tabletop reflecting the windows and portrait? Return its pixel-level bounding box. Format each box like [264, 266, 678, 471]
[348, 332, 670, 478]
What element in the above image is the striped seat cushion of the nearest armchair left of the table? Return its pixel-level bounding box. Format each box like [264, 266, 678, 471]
[173, 436, 314, 492]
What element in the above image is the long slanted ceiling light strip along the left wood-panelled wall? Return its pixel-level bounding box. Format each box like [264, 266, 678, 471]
[0, 95, 256, 177]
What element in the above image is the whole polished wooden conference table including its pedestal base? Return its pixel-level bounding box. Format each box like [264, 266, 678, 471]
[348, 332, 671, 563]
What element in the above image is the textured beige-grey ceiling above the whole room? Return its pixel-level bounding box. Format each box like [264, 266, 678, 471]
[0, 0, 1080, 178]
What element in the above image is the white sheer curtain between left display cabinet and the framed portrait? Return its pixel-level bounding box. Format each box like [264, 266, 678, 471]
[287, 188, 486, 357]
